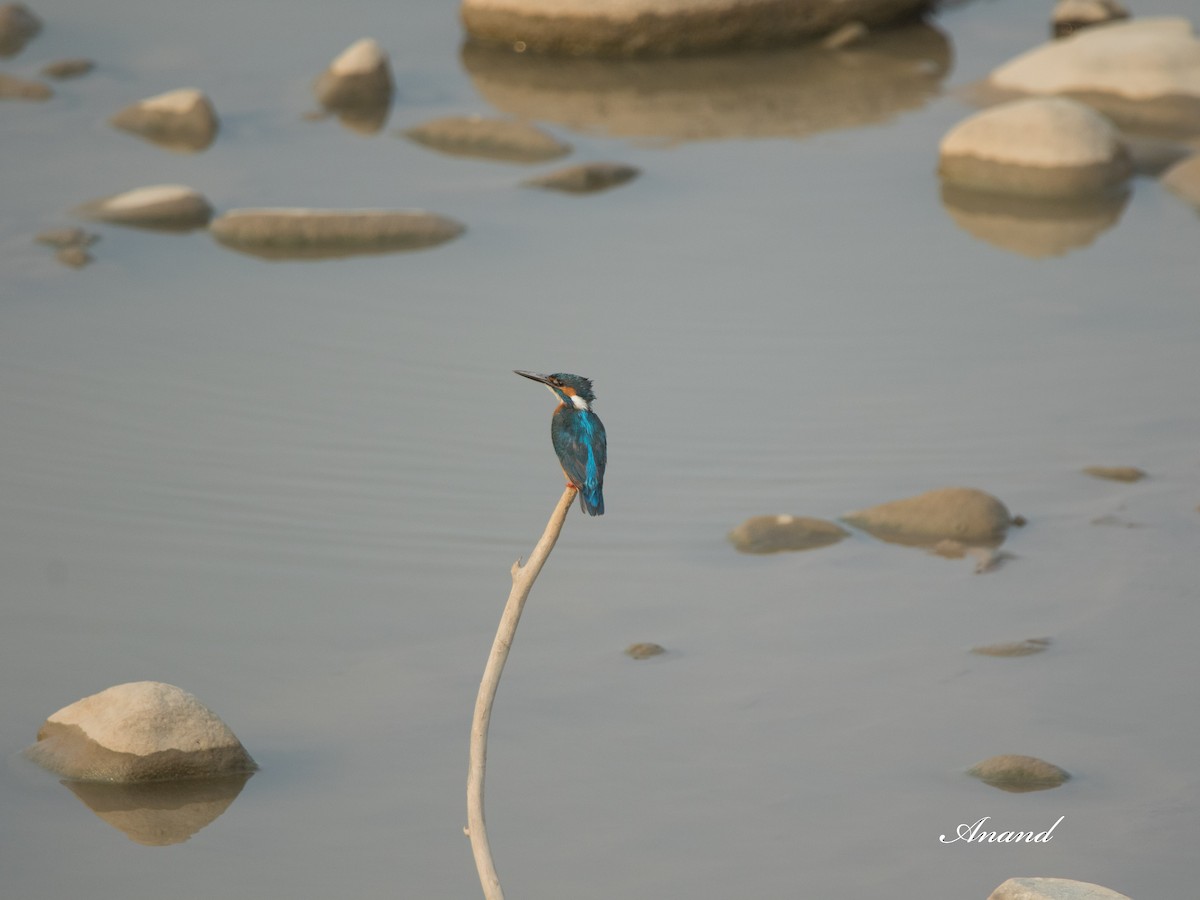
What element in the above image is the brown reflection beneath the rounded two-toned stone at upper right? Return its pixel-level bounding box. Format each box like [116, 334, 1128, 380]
[942, 185, 1129, 258]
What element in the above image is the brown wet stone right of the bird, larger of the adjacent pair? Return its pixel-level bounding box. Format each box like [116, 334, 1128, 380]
[841, 487, 1013, 546]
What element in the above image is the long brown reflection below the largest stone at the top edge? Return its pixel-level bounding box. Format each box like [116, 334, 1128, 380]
[462, 24, 952, 140]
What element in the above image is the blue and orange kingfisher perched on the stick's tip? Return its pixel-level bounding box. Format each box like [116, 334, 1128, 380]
[512, 368, 608, 516]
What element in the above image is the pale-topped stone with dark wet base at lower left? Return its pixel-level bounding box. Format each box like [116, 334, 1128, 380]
[25, 682, 257, 782]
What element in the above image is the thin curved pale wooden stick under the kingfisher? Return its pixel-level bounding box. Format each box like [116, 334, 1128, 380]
[466, 485, 575, 900]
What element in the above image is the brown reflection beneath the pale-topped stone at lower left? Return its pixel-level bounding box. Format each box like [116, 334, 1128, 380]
[62, 774, 250, 847]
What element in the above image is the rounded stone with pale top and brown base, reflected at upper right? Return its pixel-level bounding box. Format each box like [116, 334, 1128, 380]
[938, 97, 1133, 198]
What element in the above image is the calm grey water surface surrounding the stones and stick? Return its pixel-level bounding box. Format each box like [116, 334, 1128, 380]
[0, 0, 1200, 900]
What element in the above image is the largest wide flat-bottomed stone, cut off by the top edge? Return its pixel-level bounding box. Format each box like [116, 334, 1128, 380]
[460, 0, 928, 56]
